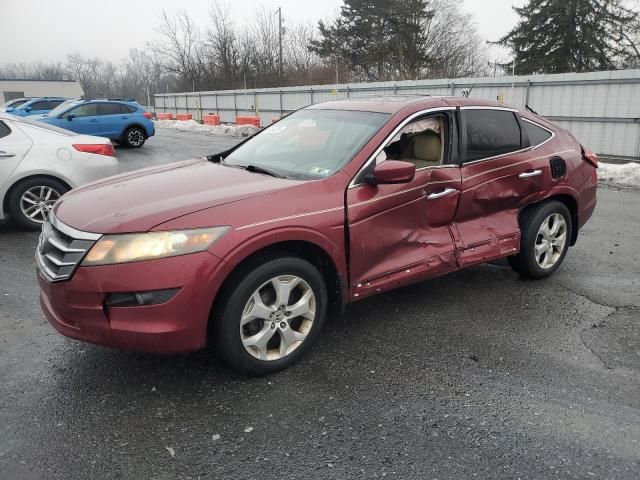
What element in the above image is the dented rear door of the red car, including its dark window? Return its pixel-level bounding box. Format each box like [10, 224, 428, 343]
[452, 107, 549, 267]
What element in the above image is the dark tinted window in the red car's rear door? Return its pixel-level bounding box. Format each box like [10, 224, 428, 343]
[464, 109, 522, 162]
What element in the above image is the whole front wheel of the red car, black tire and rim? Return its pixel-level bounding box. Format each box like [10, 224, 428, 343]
[211, 256, 328, 375]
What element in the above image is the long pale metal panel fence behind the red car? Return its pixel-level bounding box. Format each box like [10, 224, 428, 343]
[155, 70, 640, 159]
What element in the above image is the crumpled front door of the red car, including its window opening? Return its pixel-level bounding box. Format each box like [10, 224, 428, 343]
[347, 111, 460, 299]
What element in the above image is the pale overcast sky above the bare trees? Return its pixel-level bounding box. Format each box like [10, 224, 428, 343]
[0, 0, 523, 65]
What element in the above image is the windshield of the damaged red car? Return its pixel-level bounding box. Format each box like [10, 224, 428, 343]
[223, 110, 389, 180]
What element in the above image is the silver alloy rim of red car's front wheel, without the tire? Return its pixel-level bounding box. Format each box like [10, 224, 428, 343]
[240, 275, 316, 361]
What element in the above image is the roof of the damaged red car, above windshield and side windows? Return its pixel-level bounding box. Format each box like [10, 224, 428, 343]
[307, 95, 504, 114]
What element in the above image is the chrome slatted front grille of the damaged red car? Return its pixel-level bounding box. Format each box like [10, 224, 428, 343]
[36, 213, 101, 282]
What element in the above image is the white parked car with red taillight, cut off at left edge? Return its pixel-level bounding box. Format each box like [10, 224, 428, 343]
[0, 113, 118, 230]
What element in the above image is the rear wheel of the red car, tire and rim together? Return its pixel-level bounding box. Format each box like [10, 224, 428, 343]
[508, 201, 573, 280]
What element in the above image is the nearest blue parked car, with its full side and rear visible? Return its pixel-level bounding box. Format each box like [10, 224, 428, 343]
[36, 99, 155, 148]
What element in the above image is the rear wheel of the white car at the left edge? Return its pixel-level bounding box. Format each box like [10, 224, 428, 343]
[8, 177, 69, 230]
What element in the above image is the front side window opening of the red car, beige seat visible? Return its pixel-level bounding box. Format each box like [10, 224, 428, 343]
[376, 115, 446, 169]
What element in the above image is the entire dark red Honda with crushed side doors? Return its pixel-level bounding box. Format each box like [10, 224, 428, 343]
[36, 97, 597, 374]
